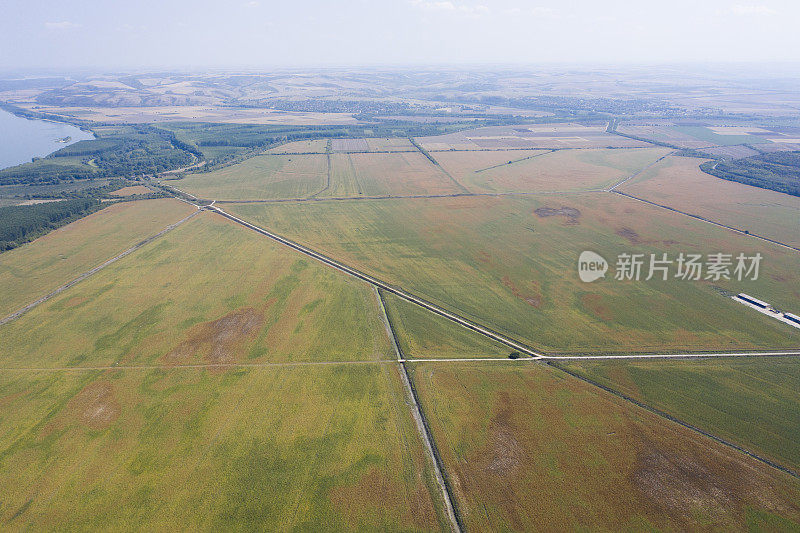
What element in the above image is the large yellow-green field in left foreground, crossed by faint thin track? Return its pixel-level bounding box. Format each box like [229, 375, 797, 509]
[0, 212, 446, 530]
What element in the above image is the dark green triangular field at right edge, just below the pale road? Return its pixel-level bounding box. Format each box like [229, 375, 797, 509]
[565, 358, 800, 471]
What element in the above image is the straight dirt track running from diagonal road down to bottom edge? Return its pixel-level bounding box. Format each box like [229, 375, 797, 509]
[372, 285, 462, 533]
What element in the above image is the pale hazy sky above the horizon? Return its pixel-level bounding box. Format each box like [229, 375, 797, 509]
[0, 0, 800, 68]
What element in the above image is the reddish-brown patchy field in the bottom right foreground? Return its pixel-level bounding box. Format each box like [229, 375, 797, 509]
[412, 363, 800, 531]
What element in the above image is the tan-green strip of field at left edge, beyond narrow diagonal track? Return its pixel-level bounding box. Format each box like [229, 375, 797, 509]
[0, 199, 194, 316]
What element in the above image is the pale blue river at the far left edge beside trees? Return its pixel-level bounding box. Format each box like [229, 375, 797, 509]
[0, 109, 94, 169]
